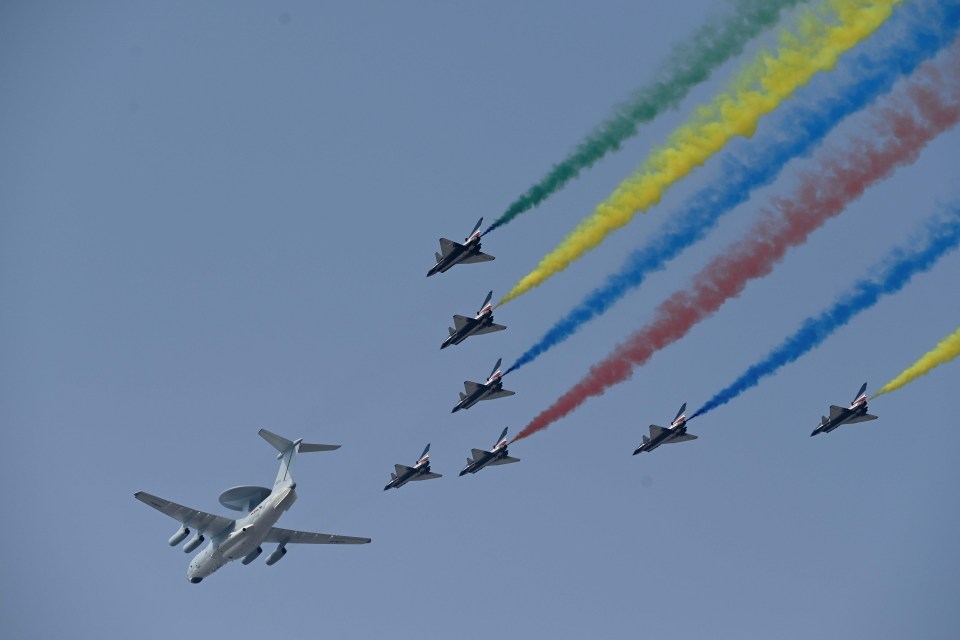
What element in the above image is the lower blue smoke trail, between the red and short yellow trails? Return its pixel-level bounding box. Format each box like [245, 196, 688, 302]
[689, 202, 960, 420]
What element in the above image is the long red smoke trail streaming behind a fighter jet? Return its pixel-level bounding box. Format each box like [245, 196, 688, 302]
[512, 43, 960, 442]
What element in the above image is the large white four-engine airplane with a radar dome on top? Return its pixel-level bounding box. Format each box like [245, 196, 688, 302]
[133, 429, 370, 584]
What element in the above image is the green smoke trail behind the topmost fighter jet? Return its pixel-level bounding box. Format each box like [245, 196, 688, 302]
[483, 0, 801, 235]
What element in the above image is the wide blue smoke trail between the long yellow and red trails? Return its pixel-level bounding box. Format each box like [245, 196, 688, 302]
[504, 0, 960, 375]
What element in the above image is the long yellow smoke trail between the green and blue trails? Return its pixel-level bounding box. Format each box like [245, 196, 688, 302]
[497, 0, 900, 305]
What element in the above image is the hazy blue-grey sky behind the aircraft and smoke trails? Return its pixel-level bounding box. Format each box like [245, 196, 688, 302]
[0, 0, 960, 639]
